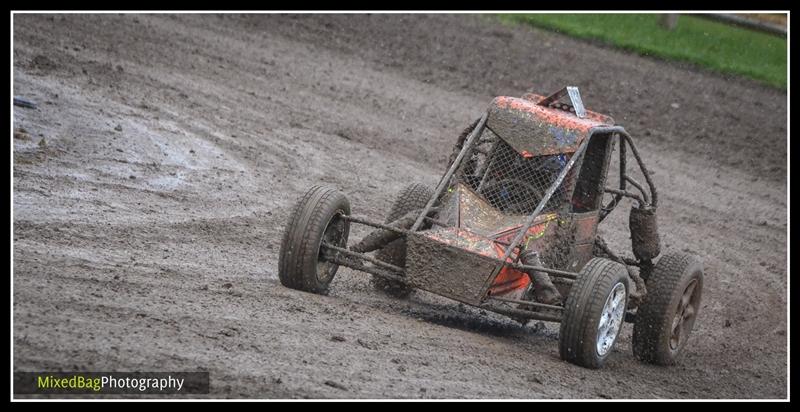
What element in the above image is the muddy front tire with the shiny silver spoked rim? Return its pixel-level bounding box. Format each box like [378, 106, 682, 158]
[558, 257, 630, 369]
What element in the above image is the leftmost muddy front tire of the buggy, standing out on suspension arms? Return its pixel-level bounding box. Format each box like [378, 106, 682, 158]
[278, 186, 350, 294]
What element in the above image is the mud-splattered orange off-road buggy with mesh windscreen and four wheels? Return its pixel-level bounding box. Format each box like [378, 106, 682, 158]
[278, 87, 703, 368]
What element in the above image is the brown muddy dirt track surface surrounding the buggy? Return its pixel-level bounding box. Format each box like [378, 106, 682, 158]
[13, 15, 787, 398]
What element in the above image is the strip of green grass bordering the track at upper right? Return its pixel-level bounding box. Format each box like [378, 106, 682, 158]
[498, 14, 787, 89]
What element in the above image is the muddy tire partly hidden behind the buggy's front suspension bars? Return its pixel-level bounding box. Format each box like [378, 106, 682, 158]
[372, 183, 433, 299]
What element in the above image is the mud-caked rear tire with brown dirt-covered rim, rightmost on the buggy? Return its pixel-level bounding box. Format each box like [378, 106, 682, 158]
[633, 252, 703, 366]
